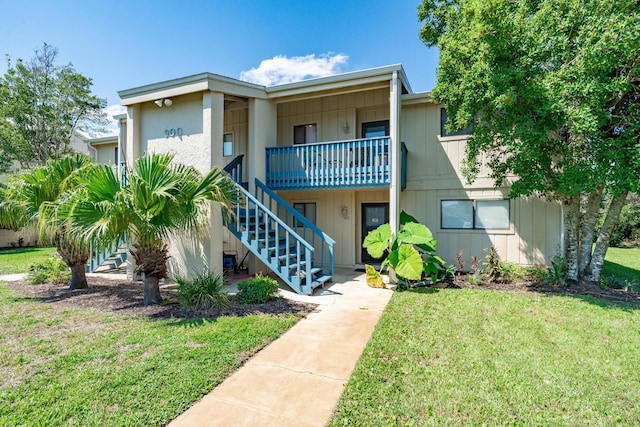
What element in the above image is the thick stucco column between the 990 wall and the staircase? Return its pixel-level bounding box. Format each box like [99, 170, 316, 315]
[201, 92, 224, 274]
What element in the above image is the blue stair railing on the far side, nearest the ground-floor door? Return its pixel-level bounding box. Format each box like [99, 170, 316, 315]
[255, 178, 336, 276]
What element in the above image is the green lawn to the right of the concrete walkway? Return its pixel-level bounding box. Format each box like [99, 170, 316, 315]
[330, 289, 640, 426]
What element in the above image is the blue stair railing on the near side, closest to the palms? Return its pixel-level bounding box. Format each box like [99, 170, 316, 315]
[228, 183, 314, 295]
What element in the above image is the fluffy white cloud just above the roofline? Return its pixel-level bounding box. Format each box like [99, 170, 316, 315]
[240, 53, 349, 86]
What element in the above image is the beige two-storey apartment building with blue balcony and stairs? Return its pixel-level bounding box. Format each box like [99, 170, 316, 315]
[114, 65, 562, 293]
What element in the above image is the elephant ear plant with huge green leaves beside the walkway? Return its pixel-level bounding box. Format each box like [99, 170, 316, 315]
[363, 211, 445, 287]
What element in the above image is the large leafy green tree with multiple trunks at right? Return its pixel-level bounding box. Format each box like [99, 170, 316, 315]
[418, 0, 640, 282]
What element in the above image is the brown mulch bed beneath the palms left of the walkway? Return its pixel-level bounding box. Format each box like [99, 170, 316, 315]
[7, 277, 317, 319]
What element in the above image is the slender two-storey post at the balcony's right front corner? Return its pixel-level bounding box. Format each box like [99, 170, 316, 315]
[389, 71, 402, 237]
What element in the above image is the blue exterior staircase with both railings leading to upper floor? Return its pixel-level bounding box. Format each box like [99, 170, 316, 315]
[225, 156, 335, 295]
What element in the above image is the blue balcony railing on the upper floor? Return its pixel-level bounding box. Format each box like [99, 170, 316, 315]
[266, 137, 390, 190]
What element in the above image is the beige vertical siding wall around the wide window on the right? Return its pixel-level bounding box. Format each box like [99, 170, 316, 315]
[400, 102, 562, 267]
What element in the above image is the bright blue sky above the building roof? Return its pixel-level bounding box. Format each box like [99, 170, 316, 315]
[0, 0, 437, 117]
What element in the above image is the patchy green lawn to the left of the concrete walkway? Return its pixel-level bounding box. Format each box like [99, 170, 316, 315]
[0, 284, 298, 426]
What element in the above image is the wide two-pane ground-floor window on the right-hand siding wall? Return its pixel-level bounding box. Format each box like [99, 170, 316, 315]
[440, 200, 510, 230]
